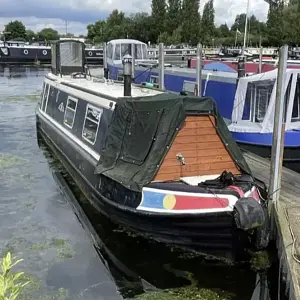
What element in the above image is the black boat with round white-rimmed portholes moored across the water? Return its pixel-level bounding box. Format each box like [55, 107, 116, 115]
[0, 46, 103, 64]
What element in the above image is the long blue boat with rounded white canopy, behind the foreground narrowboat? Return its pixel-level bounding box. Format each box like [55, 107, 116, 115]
[107, 39, 237, 119]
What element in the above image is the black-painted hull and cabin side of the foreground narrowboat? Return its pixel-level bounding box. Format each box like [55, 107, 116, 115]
[37, 79, 260, 260]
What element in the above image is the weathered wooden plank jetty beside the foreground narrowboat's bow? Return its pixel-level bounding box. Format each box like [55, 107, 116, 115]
[244, 152, 300, 300]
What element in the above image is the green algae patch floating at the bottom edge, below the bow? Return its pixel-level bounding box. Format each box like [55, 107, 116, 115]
[134, 287, 232, 300]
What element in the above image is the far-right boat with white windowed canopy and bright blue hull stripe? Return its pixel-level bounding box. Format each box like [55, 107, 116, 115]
[228, 69, 300, 172]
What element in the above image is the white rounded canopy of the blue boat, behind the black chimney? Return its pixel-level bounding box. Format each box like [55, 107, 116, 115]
[107, 39, 148, 64]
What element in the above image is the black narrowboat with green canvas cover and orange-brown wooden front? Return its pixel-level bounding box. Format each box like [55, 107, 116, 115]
[36, 41, 268, 260]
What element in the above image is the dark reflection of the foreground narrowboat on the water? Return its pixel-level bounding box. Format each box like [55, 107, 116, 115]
[38, 139, 262, 299]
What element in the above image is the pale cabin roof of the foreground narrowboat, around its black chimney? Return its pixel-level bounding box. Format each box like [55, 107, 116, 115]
[47, 73, 162, 100]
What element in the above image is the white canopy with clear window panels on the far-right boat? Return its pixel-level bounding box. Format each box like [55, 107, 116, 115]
[229, 69, 300, 133]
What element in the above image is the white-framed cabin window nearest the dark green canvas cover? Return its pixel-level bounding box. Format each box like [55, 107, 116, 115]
[82, 104, 103, 145]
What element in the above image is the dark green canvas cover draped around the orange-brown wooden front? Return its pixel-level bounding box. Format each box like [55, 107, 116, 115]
[95, 93, 251, 191]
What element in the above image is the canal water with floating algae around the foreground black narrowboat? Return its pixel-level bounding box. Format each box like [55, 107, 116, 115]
[0, 66, 277, 300]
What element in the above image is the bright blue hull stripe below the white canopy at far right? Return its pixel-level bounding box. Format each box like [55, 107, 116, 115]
[231, 131, 300, 147]
